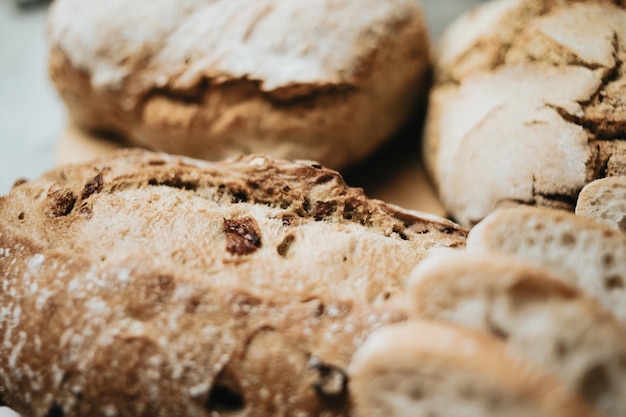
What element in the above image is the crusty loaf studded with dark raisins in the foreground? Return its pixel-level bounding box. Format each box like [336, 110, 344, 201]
[0, 151, 467, 417]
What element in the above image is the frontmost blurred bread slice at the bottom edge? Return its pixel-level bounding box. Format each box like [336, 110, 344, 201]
[349, 320, 594, 417]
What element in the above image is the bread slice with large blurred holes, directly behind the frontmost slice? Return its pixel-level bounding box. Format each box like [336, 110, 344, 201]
[409, 251, 626, 416]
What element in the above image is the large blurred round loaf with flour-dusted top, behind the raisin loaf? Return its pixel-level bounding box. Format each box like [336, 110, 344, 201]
[49, 0, 429, 167]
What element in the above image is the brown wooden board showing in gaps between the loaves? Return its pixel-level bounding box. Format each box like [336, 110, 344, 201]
[57, 122, 445, 216]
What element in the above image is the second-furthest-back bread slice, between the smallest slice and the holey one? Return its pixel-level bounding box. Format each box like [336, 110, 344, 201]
[467, 206, 626, 325]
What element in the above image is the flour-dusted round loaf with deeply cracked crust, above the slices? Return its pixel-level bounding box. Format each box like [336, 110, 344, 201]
[423, 0, 626, 225]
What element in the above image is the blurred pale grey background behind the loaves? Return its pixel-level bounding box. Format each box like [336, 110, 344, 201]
[0, 0, 481, 195]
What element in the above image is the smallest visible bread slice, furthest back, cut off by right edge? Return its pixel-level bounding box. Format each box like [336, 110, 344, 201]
[576, 176, 626, 233]
